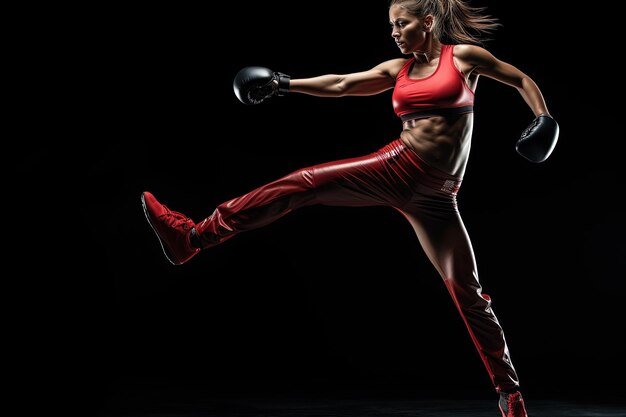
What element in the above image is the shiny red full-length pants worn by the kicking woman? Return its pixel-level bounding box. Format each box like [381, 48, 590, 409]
[196, 139, 519, 392]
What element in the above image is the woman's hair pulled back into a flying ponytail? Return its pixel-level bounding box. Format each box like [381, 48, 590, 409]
[389, 0, 501, 44]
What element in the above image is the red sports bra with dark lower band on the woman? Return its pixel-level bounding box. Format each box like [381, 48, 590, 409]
[392, 45, 474, 122]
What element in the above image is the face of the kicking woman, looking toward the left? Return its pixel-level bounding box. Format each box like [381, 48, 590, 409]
[389, 5, 432, 54]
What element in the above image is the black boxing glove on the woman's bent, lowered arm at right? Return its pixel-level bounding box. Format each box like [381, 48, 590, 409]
[515, 114, 559, 162]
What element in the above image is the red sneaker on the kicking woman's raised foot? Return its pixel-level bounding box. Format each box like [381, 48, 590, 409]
[141, 191, 200, 265]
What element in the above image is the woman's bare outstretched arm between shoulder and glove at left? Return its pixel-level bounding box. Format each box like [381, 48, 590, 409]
[289, 58, 406, 97]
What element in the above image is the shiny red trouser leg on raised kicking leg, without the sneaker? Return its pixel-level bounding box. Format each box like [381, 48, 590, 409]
[196, 147, 411, 248]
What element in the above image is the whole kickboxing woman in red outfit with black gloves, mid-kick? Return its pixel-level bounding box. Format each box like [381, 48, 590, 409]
[142, 0, 558, 417]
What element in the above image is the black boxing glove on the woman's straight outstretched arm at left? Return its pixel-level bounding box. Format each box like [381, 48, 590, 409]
[233, 66, 291, 104]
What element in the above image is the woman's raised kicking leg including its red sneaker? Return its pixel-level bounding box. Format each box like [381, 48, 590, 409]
[142, 142, 412, 265]
